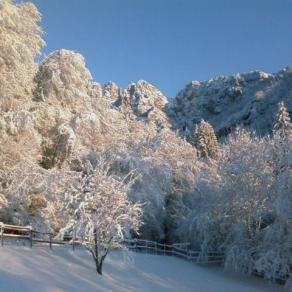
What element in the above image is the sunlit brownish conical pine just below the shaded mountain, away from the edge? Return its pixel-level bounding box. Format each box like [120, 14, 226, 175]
[194, 120, 219, 159]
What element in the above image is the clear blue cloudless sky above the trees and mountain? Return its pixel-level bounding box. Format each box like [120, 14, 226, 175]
[24, 0, 292, 97]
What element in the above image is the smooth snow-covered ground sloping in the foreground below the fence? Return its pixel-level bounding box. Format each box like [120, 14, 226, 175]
[0, 246, 285, 292]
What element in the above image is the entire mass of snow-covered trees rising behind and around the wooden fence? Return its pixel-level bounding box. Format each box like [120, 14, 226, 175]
[0, 0, 292, 279]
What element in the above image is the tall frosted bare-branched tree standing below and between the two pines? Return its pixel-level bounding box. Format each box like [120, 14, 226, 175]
[219, 129, 275, 273]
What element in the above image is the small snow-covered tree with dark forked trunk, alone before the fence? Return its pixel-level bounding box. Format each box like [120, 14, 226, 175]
[61, 162, 142, 274]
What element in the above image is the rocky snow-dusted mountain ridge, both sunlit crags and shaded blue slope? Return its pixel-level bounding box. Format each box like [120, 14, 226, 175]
[102, 68, 292, 137]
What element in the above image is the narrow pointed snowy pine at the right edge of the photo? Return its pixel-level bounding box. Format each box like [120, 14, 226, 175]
[273, 101, 292, 139]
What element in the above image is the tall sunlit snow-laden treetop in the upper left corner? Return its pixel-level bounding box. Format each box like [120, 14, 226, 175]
[0, 0, 44, 111]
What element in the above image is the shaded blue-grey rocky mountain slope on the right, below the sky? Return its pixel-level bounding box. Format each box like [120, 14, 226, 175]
[167, 68, 292, 136]
